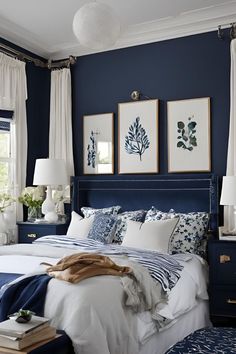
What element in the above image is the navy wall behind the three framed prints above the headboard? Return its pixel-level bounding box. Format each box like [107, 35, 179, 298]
[72, 32, 230, 175]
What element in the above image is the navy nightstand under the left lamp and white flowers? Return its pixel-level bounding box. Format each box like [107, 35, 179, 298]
[17, 222, 68, 243]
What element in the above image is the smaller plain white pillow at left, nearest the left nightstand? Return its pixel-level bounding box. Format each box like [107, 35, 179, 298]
[67, 211, 94, 238]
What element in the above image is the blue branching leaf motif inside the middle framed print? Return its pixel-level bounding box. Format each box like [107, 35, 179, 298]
[125, 117, 150, 161]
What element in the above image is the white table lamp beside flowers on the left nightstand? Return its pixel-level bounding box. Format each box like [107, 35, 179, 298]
[33, 159, 67, 222]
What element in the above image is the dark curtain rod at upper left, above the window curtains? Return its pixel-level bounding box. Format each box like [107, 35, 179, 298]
[0, 43, 76, 69]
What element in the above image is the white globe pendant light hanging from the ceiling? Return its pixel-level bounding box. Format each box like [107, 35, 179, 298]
[73, 2, 120, 50]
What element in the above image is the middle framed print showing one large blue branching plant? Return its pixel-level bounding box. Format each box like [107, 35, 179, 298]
[118, 99, 158, 174]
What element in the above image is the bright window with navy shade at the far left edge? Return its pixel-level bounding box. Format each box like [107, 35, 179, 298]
[0, 110, 13, 193]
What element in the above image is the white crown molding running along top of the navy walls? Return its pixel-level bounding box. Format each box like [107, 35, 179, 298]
[0, 0, 236, 60]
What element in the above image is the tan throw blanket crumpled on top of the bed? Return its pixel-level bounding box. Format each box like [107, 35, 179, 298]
[46, 252, 132, 283]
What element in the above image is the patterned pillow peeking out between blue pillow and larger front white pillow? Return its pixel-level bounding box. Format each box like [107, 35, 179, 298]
[113, 210, 146, 244]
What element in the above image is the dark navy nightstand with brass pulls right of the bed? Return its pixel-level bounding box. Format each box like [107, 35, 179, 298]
[208, 240, 236, 325]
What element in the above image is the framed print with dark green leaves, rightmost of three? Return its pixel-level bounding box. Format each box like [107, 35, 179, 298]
[167, 97, 211, 172]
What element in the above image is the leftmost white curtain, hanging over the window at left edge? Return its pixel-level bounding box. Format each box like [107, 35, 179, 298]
[0, 53, 27, 220]
